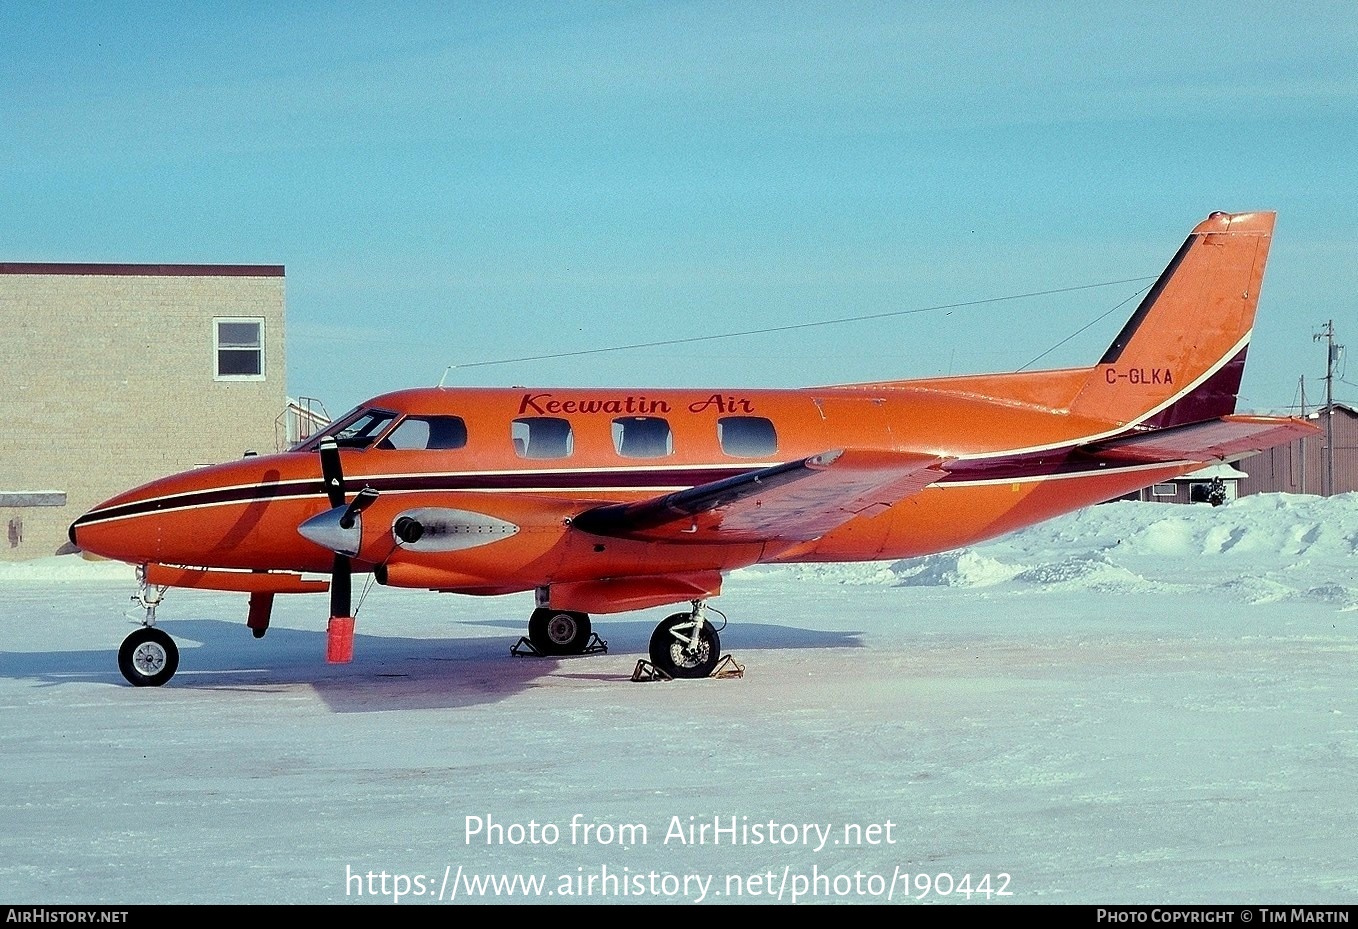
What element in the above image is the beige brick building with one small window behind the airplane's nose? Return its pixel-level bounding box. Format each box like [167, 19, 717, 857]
[0, 263, 288, 560]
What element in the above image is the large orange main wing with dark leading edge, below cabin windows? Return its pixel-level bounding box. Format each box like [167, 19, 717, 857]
[572, 448, 947, 542]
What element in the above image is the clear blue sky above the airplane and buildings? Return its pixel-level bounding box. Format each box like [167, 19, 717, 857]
[0, 1, 1358, 413]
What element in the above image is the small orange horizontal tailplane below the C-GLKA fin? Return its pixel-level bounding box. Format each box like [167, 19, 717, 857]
[1081, 416, 1320, 462]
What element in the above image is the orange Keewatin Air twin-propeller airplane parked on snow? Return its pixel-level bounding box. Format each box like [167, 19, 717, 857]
[71, 213, 1316, 686]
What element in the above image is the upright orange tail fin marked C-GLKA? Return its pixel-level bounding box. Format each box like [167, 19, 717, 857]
[1070, 213, 1275, 428]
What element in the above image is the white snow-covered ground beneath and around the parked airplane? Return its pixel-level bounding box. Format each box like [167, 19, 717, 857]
[0, 496, 1358, 903]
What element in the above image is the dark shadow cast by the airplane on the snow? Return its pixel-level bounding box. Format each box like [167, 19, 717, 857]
[0, 619, 862, 713]
